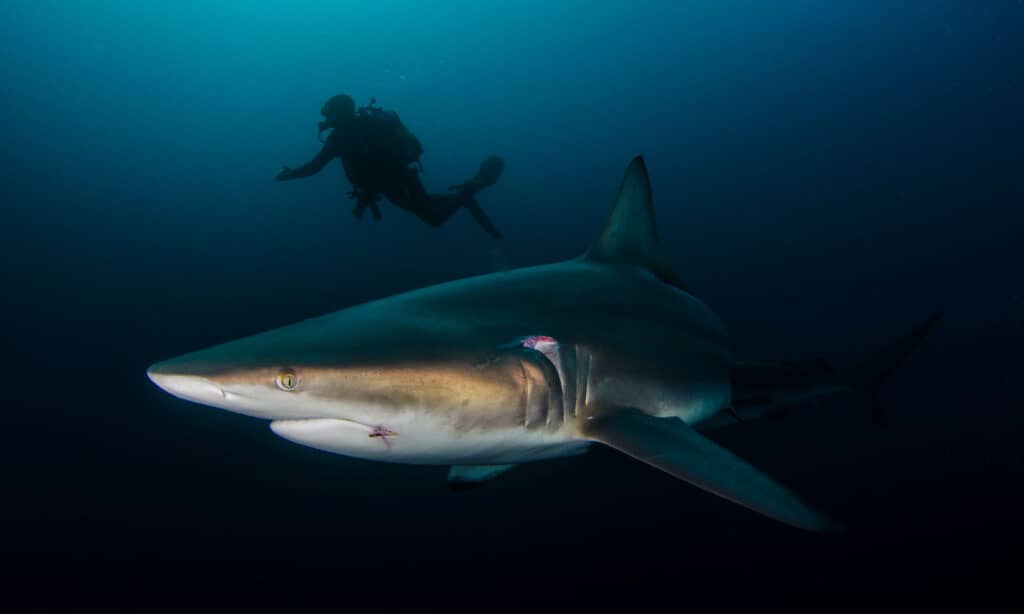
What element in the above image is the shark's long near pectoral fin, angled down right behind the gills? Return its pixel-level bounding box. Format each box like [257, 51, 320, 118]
[586, 409, 838, 531]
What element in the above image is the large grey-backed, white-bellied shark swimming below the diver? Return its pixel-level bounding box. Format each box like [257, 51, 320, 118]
[147, 157, 938, 531]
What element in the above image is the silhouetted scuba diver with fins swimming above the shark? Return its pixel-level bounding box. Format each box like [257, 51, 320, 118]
[274, 94, 505, 238]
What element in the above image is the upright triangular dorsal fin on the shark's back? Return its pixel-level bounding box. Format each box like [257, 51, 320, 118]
[584, 156, 686, 291]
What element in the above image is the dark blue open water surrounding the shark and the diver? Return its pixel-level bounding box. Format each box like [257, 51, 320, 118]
[0, 0, 1024, 608]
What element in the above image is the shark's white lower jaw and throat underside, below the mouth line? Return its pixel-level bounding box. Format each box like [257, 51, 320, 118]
[270, 413, 590, 465]
